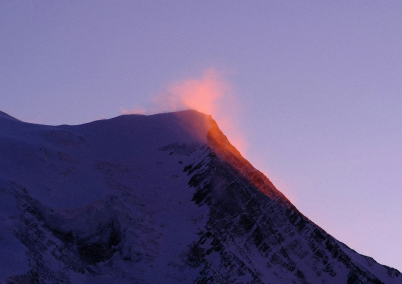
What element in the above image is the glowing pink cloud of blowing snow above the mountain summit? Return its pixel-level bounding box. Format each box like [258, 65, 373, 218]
[121, 68, 246, 154]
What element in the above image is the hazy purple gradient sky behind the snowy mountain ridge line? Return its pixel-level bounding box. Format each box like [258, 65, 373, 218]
[0, 0, 402, 271]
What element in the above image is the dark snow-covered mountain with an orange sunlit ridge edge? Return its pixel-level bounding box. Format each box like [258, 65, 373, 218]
[0, 110, 402, 284]
